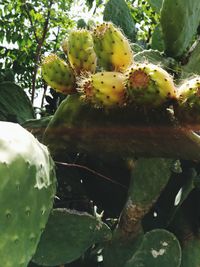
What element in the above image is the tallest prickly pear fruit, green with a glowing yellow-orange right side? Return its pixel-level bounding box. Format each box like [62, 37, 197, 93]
[93, 23, 133, 72]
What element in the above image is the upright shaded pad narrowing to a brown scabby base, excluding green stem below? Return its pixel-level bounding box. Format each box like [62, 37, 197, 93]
[119, 158, 173, 235]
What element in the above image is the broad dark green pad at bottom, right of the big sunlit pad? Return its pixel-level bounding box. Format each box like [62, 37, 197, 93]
[33, 209, 111, 266]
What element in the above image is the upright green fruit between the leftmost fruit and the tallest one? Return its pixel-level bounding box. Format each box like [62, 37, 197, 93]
[65, 29, 97, 74]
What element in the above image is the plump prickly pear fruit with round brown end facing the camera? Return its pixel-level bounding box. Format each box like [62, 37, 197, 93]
[126, 63, 176, 108]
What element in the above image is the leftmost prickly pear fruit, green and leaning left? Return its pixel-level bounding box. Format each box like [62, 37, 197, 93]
[41, 54, 75, 94]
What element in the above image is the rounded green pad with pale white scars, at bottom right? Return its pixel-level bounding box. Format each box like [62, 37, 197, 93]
[125, 229, 182, 267]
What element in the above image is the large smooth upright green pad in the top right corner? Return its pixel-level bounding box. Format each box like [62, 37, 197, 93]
[161, 0, 200, 57]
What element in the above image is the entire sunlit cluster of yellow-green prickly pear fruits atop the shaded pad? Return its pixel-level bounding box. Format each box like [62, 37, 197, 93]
[41, 22, 199, 123]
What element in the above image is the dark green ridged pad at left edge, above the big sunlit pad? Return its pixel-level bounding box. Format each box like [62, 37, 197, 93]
[0, 82, 34, 124]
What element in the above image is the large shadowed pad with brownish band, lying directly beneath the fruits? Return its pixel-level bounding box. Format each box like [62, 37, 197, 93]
[43, 95, 200, 159]
